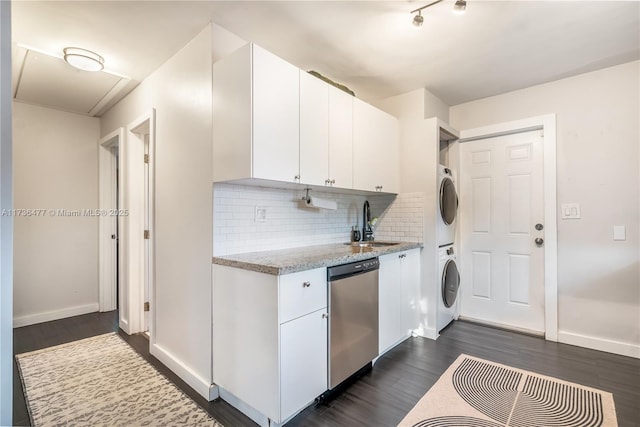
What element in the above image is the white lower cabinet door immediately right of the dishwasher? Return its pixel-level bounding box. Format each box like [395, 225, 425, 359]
[378, 254, 404, 354]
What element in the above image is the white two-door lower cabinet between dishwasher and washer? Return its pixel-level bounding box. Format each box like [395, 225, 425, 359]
[378, 249, 420, 354]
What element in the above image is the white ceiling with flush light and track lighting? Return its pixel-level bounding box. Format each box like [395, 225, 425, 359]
[12, 0, 640, 116]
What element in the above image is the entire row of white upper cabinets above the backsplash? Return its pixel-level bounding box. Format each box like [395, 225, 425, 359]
[213, 44, 399, 193]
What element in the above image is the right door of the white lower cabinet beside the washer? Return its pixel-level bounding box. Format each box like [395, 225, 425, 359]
[400, 249, 420, 336]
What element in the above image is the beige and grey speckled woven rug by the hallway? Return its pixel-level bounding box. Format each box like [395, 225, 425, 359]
[16, 333, 221, 427]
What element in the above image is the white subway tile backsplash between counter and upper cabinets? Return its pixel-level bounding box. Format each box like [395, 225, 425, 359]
[213, 183, 424, 256]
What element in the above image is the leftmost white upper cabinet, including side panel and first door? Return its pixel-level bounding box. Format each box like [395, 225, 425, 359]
[213, 44, 300, 182]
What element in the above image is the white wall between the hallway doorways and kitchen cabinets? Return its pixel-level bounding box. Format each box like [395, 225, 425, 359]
[101, 26, 213, 398]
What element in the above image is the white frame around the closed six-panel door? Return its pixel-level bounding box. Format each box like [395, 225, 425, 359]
[458, 114, 558, 341]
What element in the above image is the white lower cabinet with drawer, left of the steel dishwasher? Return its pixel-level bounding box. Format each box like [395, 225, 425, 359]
[213, 265, 328, 426]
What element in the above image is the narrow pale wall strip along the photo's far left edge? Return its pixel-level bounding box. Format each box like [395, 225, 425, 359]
[0, 1, 13, 426]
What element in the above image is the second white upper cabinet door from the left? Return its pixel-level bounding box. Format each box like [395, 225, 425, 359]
[300, 70, 329, 185]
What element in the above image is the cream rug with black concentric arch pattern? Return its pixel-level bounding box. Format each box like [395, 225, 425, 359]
[399, 354, 618, 427]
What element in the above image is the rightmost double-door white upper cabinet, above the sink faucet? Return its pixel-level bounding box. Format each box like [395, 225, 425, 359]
[353, 99, 399, 193]
